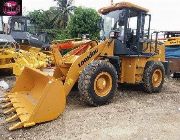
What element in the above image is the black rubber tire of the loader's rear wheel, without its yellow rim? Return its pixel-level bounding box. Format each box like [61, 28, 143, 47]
[143, 61, 165, 93]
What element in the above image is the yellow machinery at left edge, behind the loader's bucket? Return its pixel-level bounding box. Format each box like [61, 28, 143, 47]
[0, 34, 48, 76]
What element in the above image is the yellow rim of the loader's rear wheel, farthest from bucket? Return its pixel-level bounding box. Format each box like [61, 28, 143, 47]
[152, 69, 162, 87]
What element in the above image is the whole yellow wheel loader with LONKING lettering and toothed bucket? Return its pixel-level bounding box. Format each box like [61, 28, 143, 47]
[2, 2, 166, 130]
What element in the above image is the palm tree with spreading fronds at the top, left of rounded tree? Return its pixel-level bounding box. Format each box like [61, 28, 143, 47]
[52, 0, 75, 29]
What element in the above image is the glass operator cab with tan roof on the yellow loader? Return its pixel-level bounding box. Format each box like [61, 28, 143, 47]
[99, 2, 151, 55]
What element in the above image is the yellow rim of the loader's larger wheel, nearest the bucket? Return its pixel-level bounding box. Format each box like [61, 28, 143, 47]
[94, 72, 112, 97]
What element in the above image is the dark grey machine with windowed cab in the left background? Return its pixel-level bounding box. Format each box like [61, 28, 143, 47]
[8, 16, 52, 50]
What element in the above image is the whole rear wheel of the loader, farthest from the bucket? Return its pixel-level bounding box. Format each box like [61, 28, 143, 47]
[143, 61, 165, 93]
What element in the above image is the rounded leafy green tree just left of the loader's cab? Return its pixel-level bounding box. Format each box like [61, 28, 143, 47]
[68, 7, 100, 39]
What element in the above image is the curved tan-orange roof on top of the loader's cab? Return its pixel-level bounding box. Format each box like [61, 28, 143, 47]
[98, 2, 149, 15]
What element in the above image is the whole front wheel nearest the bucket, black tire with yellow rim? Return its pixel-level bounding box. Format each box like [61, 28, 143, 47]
[78, 60, 117, 106]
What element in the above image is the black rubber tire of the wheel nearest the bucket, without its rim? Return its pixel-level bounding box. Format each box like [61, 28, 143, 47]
[78, 60, 117, 106]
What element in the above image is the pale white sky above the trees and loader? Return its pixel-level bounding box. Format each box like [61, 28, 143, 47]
[4, 0, 180, 31]
